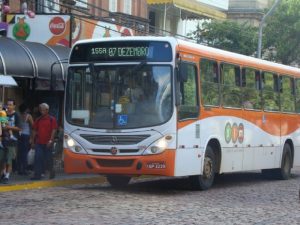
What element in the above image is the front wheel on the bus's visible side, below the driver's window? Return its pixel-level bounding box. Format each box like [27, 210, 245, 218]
[189, 146, 216, 190]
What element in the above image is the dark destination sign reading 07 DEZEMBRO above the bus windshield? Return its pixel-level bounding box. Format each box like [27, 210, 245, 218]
[70, 41, 172, 63]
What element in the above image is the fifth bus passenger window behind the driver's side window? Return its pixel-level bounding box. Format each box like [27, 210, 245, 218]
[280, 76, 295, 112]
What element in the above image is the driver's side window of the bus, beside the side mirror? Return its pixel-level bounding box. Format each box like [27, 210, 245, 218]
[179, 62, 199, 120]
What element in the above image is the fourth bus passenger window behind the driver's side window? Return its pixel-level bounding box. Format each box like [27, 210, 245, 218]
[262, 72, 279, 111]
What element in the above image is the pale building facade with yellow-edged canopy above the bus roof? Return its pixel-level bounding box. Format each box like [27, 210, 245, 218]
[147, 0, 228, 38]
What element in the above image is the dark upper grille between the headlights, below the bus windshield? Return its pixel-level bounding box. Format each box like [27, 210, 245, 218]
[80, 134, 150, 145]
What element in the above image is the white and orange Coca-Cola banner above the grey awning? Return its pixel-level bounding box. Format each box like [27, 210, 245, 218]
[6, 14, 134, 47]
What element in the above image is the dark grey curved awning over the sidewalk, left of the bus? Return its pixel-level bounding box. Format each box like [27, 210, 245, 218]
[0, 37, 70, 80]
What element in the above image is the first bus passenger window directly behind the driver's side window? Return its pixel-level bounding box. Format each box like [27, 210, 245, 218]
[200, 59, 220, 106]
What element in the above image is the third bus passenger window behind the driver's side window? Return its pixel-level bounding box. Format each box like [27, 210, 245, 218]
[242, 68, 262, 109]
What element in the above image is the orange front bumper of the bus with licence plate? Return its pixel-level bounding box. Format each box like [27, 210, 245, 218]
[64, 149, 175, 176]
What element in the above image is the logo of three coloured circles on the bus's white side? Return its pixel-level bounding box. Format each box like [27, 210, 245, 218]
[224, 122, 244, 143]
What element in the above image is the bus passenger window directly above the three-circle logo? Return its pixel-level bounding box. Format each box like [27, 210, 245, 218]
[221, 63, 242, 108]
